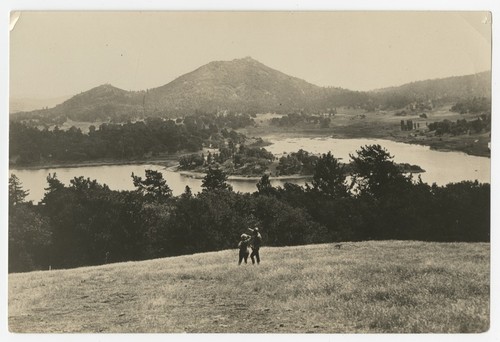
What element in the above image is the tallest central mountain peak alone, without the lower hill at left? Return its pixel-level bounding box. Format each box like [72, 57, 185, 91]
[146, 57, 332, 114]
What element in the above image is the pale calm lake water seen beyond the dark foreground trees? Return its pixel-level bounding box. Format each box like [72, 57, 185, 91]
[10, 136, 490, 203]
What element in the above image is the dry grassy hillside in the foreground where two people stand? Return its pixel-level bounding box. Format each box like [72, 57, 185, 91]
[9, 241, 490, 333]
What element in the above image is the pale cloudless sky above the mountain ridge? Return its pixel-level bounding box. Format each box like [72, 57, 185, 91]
[10, 11, 491, 98]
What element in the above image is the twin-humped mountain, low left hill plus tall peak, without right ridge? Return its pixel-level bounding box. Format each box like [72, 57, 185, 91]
[13, 57, 344, 123]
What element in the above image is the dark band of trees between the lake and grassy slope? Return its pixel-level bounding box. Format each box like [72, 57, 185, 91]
[9, 145, 490, 272]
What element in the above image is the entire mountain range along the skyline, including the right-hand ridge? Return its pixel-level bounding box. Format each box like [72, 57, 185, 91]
[11, 57, 491, 123]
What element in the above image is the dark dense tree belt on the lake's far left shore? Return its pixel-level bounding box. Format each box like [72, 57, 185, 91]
[9, 117, 254, 165]
